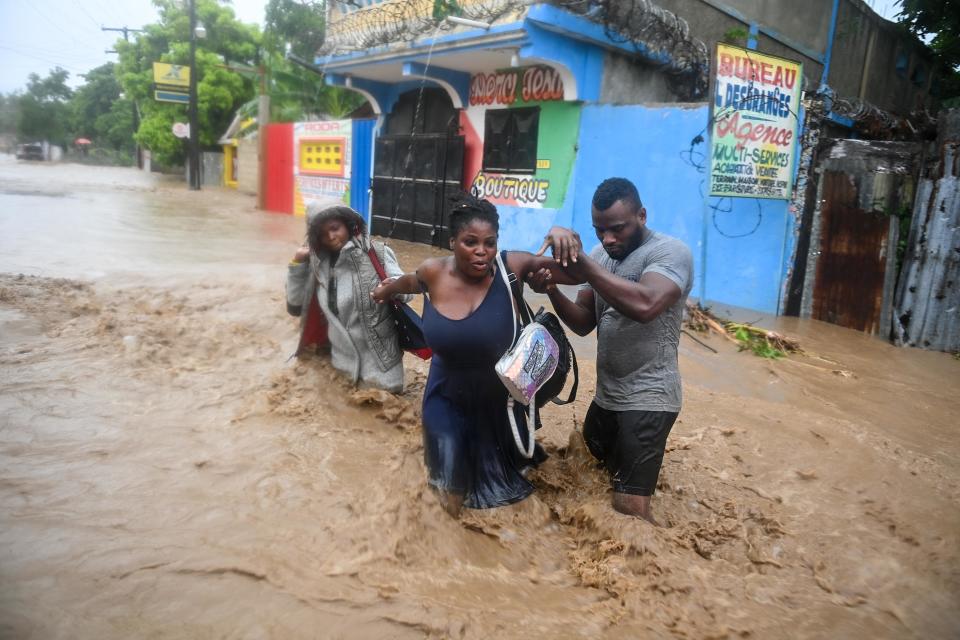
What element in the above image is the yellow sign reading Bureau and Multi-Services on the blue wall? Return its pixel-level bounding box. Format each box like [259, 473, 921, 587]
[710, 44, 803, 200]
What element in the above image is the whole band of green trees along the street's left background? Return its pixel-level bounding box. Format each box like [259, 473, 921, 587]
[0, 0, 363, 166]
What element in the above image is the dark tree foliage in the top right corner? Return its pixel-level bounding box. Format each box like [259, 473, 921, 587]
[897, 0, 960, 98]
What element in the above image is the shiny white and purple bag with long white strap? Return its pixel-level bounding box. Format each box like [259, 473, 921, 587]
[494, 253, 560, 458]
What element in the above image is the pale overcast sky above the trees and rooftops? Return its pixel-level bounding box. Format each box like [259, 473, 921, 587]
[0, 0, 897, 93]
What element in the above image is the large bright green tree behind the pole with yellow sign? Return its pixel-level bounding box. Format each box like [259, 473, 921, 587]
[116, 0, 260, 165]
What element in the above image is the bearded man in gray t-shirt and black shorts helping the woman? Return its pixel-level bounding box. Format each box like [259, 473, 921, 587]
[531, 178, 693, 524]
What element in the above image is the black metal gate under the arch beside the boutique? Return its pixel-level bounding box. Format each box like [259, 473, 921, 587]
[371, 133, 464, 246]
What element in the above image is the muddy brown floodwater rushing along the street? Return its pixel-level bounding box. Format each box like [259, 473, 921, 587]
[0, 156, 960, 640]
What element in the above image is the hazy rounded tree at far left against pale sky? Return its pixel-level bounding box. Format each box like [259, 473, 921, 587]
[17, 67, 73, 147]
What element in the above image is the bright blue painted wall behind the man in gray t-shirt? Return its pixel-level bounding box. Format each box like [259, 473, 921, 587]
[498, 104, 796, 313]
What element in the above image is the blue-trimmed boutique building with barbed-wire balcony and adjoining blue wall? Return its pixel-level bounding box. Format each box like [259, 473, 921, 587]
[316, 0, 797, 313]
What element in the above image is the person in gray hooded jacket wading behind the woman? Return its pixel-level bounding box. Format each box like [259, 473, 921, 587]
[286, 204, 410, 392]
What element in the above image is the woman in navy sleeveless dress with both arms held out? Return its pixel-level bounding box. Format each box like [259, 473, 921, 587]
[372, 194, 579, 516]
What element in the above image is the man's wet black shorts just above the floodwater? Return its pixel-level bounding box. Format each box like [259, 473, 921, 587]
[583, 402, 677, 496]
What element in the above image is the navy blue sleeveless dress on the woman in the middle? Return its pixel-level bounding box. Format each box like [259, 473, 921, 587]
[423, 252, 546, 509]
